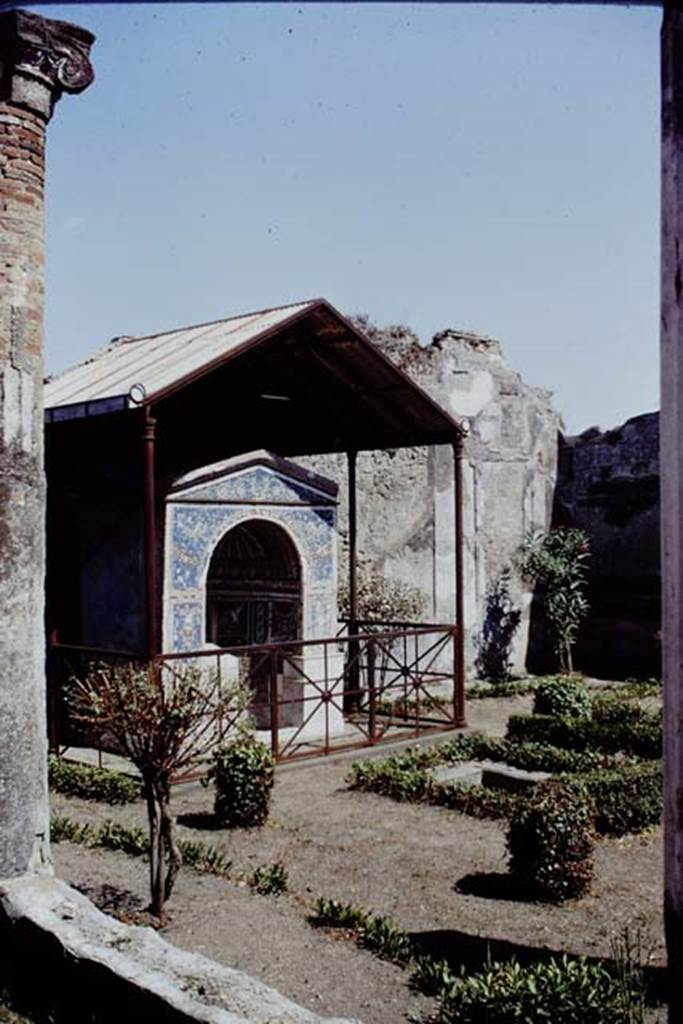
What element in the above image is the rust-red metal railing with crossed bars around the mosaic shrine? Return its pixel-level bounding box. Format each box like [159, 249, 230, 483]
[50, 623, 464, 762]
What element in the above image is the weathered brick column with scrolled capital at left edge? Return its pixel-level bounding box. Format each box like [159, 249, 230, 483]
[0, 10, 94, 878]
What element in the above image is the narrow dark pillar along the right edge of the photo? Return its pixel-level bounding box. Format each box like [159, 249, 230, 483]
[659, 0, 683, 1024]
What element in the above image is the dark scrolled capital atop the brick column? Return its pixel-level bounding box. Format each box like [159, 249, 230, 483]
[0, 10, 95, 121]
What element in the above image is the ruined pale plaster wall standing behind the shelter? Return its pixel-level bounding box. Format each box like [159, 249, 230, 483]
[301, 324, 560, 673]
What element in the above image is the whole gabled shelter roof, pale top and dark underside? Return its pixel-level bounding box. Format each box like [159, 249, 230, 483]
[45, 299, 461, 454]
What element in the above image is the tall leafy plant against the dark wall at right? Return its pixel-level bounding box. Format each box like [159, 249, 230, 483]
[518, 526, 591, 673]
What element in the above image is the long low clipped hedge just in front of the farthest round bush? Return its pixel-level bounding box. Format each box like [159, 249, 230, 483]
[507, 700, 661, 759]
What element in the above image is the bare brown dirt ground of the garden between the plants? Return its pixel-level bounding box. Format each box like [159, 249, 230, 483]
[52, 697, 664, 1024]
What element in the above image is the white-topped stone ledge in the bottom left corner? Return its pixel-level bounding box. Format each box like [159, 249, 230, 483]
[0, 876, 359, 1024]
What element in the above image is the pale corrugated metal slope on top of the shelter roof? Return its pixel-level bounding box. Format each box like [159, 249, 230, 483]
[45, 299, 319, 409]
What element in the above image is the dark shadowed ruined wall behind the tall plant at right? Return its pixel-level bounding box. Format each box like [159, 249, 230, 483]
[555, 413, 661, 678]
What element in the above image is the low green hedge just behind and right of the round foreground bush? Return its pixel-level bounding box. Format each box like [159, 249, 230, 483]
[580, 762, 661, 836]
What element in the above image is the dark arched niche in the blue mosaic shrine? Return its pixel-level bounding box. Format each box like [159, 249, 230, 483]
[206, 519, 303, 729]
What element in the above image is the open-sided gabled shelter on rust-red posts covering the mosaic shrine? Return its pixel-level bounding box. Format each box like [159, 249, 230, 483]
[45, 299, 463, 757]
